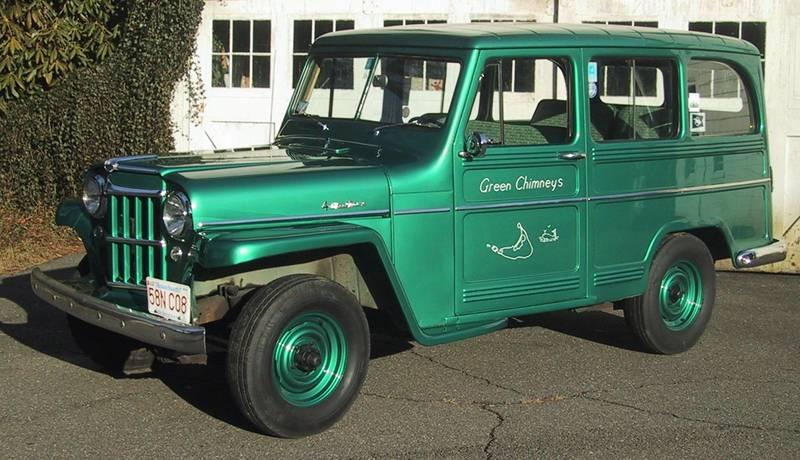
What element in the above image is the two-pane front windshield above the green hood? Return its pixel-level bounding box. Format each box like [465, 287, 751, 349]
[290, 55, 461, 127]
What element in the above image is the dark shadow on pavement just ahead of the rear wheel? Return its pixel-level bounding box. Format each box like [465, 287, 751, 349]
[509, 306, 646, 353]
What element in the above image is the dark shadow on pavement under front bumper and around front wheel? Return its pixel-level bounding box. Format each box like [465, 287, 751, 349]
[0, 267, 412, 432]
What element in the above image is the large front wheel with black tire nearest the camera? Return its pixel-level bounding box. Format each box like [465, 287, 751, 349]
[227, 275, 370, 438]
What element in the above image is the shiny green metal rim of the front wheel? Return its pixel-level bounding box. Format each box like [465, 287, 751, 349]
[272, 312, 347, 407]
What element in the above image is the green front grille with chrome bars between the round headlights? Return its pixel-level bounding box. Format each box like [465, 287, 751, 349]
[106, 187, 167, 288]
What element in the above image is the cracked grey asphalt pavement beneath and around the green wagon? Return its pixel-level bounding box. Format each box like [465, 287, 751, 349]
[0, 253, 800, 459]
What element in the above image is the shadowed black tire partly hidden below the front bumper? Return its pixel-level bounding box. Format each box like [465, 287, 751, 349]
[67, 315, 145, 374]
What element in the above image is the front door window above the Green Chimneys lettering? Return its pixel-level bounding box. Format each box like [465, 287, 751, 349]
[466, 58, 573, 145]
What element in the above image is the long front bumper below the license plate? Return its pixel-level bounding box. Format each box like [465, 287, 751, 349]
[31, 268, 206, 354]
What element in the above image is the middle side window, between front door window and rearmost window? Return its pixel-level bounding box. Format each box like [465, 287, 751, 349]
[588, 57, 678, 142]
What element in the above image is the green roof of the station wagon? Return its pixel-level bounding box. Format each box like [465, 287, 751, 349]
[314, 22, 759, 54]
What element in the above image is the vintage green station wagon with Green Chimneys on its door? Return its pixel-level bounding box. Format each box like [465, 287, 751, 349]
[31, 23, 786, 437]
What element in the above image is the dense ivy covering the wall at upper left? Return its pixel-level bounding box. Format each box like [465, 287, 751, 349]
[0, 0, 204, 209]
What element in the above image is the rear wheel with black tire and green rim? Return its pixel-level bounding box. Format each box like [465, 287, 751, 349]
[623, 233, 716, 354]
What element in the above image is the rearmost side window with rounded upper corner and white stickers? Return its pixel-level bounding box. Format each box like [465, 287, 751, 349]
[687, 59, 756, 136]
